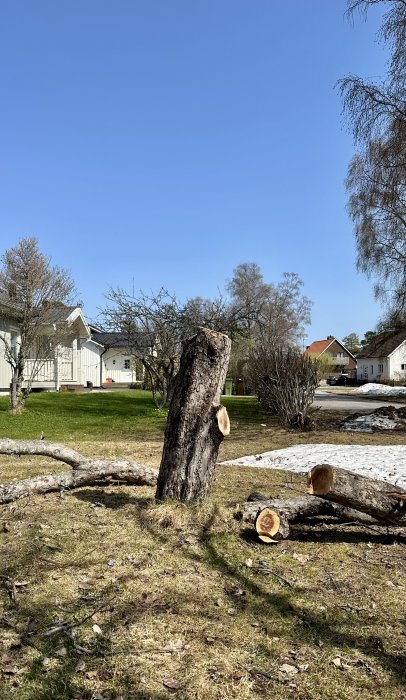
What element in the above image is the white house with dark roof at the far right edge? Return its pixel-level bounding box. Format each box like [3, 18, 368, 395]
[357, 331, 406, 383]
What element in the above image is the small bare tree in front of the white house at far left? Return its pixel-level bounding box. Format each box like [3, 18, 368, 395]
[0, 238, 74, 412]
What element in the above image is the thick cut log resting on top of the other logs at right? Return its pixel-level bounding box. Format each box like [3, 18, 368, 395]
[307, 464, 406, 526]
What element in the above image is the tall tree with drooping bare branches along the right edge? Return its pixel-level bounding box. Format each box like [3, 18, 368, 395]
[340, 0, 406, 318]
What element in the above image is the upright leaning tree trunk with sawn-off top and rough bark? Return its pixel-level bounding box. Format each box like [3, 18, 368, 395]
[156, 328, 231, 503]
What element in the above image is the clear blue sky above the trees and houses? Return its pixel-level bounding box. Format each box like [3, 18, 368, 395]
[0, 0, 385, 343]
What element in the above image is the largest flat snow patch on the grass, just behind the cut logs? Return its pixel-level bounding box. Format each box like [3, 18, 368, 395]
[222, 444, 406, 489]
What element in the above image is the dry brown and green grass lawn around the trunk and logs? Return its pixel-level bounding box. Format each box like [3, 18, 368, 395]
[0, 392, 406, 700]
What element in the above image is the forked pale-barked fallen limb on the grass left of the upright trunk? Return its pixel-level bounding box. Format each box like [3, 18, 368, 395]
[0, 440, 158, 505]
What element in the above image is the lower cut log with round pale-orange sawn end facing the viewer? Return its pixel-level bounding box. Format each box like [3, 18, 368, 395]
[241, 495, 381, 542]
